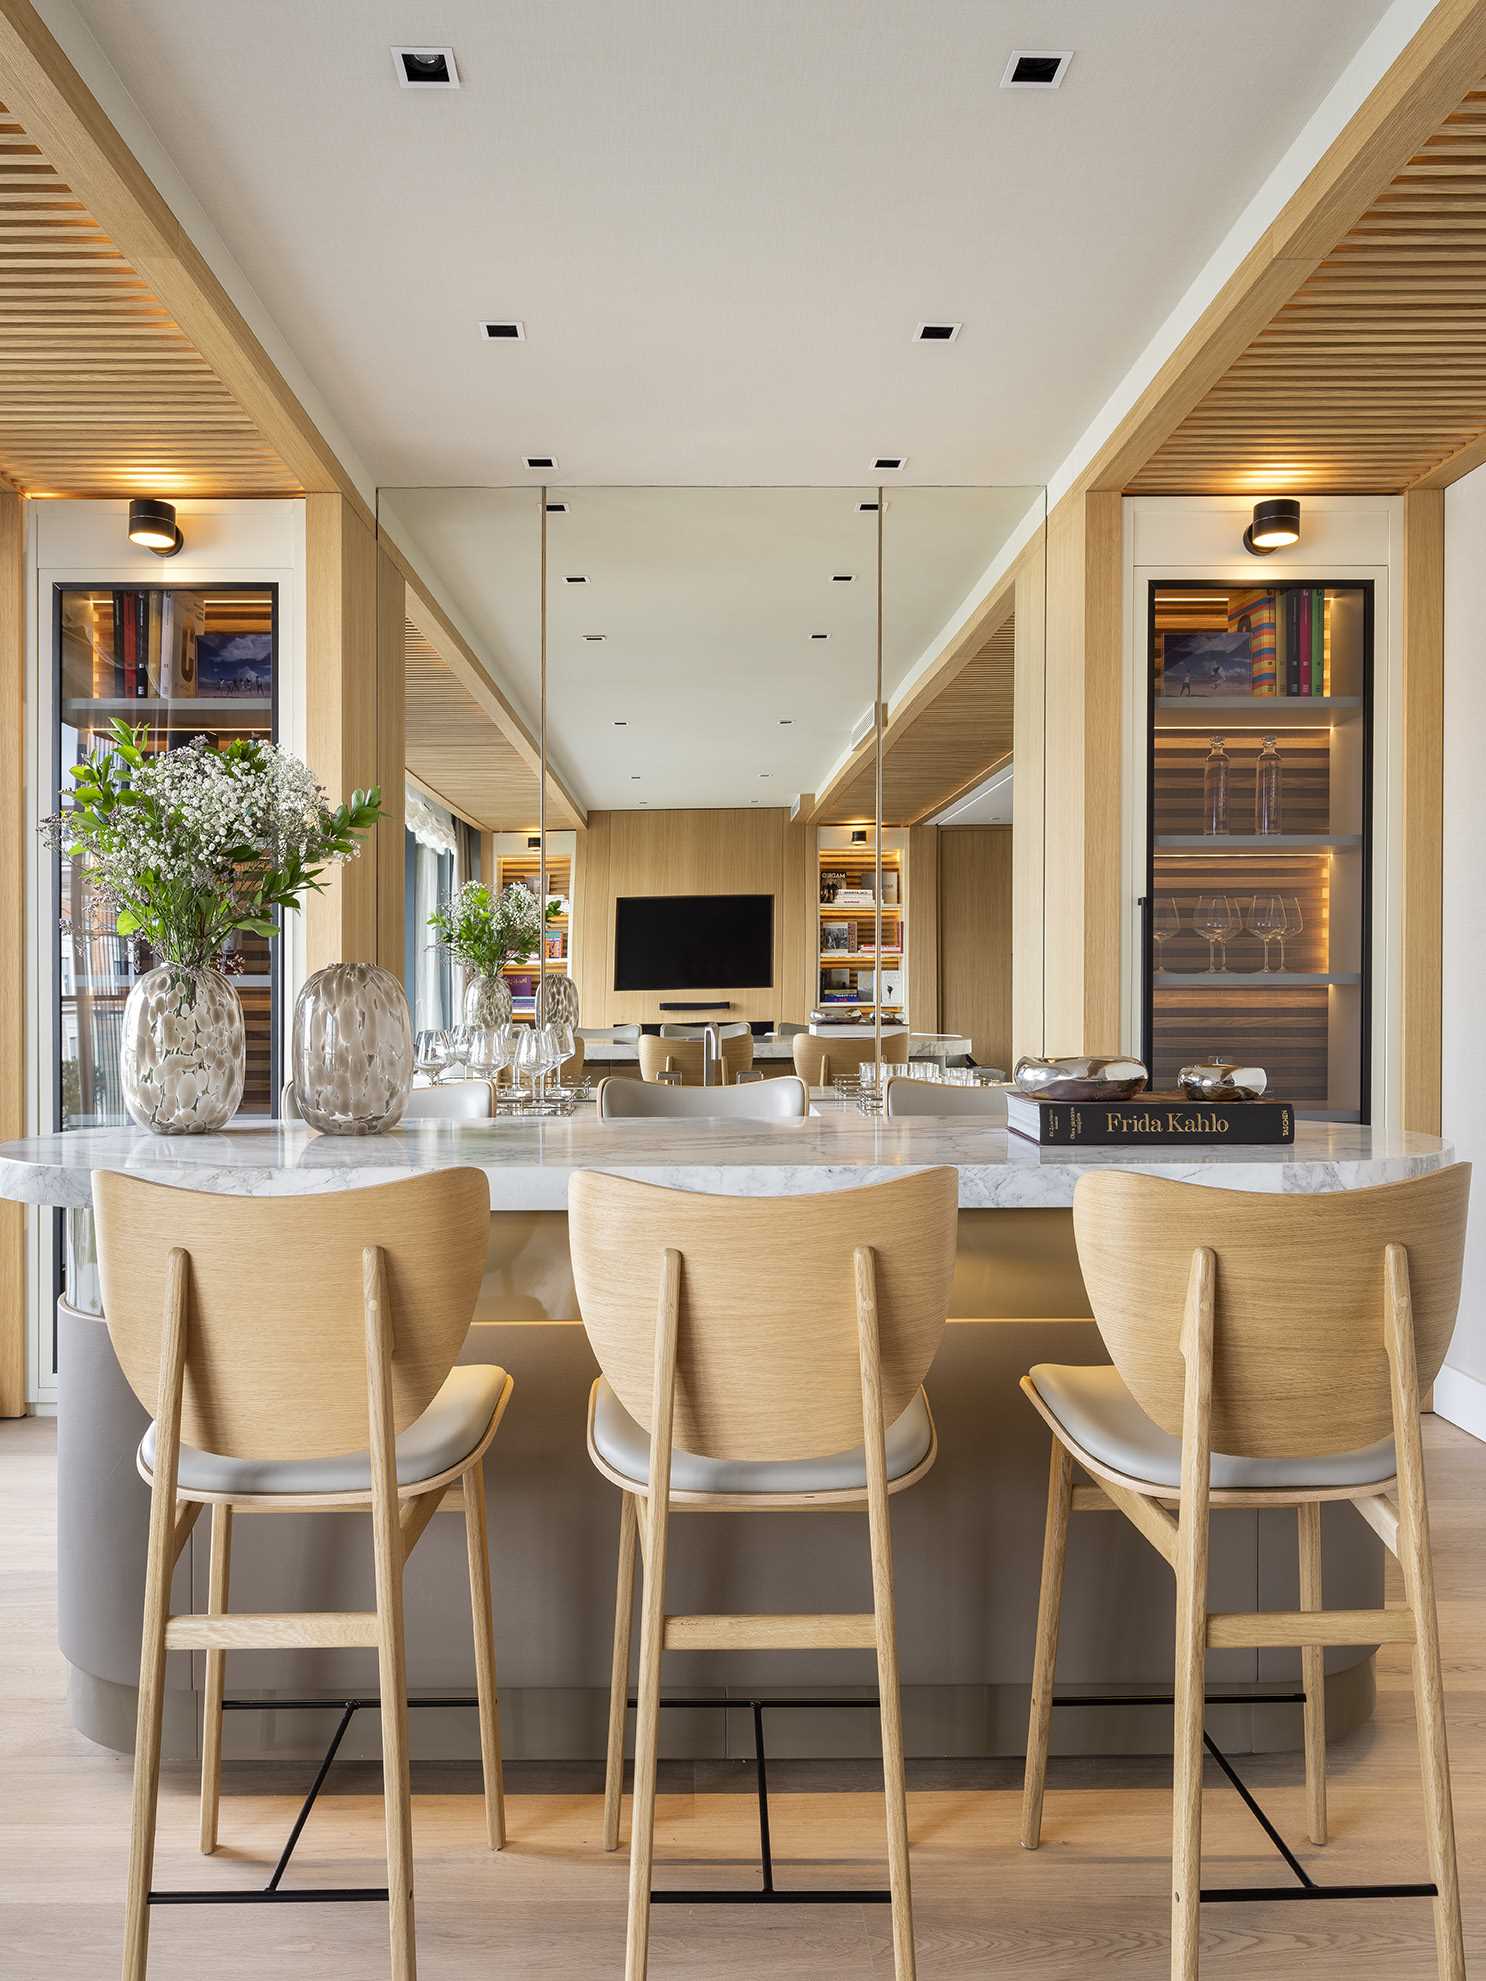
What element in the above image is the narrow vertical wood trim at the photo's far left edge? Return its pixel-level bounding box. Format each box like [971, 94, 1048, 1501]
[0, 489, 32, 1416]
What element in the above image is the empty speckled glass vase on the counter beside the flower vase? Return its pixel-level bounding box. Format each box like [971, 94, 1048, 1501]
[293, 963, 412, 1135]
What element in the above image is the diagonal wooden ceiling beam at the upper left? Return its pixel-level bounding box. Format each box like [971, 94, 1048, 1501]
[0, 0, 372, 525]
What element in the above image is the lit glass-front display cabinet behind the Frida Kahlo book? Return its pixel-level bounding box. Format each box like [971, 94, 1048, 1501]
[1143, 580, 1373, 1121]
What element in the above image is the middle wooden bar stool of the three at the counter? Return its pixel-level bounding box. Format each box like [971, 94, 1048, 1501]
[569, 1169, 957, 1981]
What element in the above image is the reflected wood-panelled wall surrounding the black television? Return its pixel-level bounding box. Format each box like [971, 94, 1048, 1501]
[573, 806, 814, 1024]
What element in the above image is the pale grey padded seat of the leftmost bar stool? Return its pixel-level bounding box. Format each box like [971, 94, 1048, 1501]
[139, 1363, 509, 1498]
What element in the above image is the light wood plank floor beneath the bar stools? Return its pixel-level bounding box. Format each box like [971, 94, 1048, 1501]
[0, 1418, 1486, 1981]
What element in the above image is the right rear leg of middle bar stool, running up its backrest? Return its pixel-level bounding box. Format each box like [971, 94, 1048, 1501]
[856, 1248, 917, 1981]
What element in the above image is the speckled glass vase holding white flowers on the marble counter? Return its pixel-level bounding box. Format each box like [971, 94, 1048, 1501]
[119, 963, 246, 1135]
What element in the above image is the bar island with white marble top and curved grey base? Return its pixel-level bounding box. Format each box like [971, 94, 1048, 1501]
[0, 1113, 1450, 1759]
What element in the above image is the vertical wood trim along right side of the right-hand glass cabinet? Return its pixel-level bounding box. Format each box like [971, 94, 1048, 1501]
[1399, 487, 1444, 1135]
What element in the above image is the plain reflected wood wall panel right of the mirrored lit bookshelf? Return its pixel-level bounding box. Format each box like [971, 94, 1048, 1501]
[939, 826, 1012, 1070]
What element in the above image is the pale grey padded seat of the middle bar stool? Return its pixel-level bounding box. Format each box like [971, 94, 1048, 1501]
[588, 1377, 935, 1500]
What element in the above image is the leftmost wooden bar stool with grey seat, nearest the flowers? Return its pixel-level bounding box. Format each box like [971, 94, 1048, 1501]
[93, 1169, 513, 1981]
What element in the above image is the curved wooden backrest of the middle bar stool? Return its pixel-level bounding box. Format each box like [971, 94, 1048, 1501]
[569, 1169, 955, 1460]
